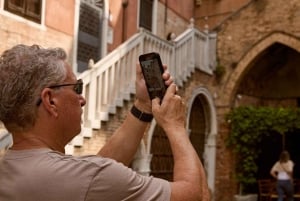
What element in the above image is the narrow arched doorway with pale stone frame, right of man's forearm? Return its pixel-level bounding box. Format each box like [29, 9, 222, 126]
[187, 87, 218, 200]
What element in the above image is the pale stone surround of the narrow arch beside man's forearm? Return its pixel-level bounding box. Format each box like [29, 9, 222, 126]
[187, 87, 217, 200]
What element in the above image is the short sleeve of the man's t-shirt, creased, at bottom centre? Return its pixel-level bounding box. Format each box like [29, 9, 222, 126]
[85, 159, 171, 201]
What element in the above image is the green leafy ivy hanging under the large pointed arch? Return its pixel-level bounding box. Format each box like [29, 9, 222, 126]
[226, 106, 300, 191]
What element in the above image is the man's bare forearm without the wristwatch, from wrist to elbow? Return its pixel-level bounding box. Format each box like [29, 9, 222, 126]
[169, 129, 209, 201]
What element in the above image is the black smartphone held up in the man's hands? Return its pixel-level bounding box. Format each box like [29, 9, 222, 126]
[139, 52, 167, 100]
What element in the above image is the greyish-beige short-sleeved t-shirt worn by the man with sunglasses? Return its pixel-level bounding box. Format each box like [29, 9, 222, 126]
[0, 149, 171, 201]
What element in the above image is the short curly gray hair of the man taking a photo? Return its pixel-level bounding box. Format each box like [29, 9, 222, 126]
[0, 44, 66, 132]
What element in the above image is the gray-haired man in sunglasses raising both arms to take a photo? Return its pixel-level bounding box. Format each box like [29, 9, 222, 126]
[0, 45, 209, 201]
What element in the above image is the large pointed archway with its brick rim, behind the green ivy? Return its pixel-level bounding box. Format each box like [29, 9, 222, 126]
[224, 32, 300, 192]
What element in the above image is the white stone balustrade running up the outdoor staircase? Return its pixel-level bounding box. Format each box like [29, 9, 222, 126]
[67, 27, 216, 152]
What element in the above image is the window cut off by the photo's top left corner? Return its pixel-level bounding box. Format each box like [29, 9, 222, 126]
[4, 0, 42, 23]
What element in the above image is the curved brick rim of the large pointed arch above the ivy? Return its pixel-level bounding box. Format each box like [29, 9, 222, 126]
[223, 32, 300, 106]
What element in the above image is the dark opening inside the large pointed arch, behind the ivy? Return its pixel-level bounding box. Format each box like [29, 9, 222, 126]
[236, 42, 300, 182]
